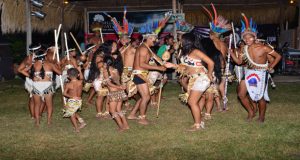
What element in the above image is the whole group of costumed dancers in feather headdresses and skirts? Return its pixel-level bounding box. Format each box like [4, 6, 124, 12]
[18, 4, 281, 132]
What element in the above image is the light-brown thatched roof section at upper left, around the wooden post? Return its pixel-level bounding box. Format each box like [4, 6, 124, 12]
[0, 0, 83, 33]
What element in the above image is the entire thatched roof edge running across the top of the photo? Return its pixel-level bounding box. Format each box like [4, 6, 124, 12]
[0, 0, 297, 33]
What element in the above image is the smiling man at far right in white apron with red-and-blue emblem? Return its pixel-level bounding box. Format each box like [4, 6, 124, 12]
[230, 14, 281, 122]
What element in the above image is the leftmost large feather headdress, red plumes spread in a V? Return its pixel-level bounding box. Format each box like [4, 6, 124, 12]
[104, 7, 134, 38]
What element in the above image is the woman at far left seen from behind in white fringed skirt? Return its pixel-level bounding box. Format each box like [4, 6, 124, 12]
[21, 47, 61, 127]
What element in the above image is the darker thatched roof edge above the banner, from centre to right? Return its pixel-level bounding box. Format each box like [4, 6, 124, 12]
[69, 0, 297, 25]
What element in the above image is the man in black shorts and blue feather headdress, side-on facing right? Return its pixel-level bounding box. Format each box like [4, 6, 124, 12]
[128, 16, 173, 125]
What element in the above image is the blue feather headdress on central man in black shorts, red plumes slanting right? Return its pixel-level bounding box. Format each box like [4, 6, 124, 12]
[139, 13, 171, 37]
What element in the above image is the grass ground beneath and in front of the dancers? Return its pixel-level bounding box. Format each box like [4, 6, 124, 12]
[0, 81, 300, 160]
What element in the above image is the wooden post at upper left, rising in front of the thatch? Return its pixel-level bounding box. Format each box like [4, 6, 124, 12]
[25, 0, 32, 55]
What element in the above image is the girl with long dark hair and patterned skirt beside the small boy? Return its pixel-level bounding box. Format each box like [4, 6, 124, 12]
[104, 55, 129, 131]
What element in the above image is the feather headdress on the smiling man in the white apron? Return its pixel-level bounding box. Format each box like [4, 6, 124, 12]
[241, 13, 257, 38]
